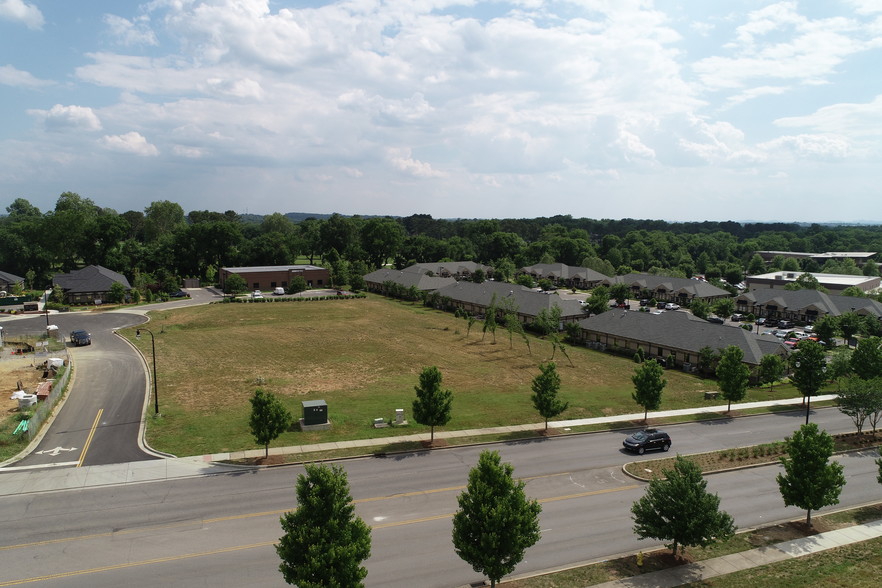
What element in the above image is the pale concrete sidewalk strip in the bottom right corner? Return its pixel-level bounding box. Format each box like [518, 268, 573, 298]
[591, 521, 882, 588]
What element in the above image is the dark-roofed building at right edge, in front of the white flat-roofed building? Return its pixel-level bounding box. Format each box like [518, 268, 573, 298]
[735, 288, 882, 323]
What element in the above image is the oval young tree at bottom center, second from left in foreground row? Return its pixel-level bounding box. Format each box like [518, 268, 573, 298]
[453, 451, 542, 586]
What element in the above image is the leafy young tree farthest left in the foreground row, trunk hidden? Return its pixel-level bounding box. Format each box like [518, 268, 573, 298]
[276, 464, 371, 588]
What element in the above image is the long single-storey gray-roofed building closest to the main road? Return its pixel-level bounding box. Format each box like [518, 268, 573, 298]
[579, 309, 788, 367]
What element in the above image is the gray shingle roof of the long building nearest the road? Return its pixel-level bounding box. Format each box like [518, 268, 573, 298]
[579, 309, 787, 365]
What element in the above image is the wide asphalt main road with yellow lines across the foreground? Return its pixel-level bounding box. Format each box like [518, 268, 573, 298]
[0, 409, 880, 588]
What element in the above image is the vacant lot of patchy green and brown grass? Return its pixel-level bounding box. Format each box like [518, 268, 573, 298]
[126, 296, 793, 455]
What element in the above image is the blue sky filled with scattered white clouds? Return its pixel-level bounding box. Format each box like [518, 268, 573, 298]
[0, 0, 882, 222]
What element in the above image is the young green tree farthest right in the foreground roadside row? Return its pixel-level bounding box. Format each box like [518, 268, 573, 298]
[776, 423, 845, 527]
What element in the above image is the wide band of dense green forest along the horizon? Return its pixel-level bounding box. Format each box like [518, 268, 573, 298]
[0, 192, 882, 291]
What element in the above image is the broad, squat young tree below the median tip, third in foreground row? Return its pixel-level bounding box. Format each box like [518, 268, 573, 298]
[631, 455, 735, 555]
